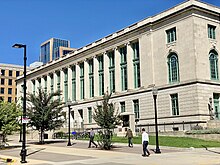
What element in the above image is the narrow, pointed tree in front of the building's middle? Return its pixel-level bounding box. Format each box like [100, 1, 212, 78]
[93, 92, 120, 150]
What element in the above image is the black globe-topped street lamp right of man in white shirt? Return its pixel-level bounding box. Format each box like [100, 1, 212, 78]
[152, 87, 161, 154]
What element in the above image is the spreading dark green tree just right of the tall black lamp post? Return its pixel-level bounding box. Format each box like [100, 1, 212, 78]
[27, 88, 64, 143]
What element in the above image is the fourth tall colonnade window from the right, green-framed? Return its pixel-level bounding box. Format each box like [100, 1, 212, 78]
[98, 55, 104, 96]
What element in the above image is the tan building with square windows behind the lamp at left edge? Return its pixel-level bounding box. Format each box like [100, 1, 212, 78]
[0, 64, 24, 102]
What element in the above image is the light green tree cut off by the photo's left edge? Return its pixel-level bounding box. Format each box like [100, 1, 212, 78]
[0, 101, 21, 142]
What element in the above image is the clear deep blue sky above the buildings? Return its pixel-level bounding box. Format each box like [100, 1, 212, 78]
[0, 0, 220, 65]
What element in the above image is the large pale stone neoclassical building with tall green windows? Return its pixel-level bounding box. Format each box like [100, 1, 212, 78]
[17, 0, 220, 134]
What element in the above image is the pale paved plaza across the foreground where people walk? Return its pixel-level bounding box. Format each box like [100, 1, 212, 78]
[0, 136, 220, 165]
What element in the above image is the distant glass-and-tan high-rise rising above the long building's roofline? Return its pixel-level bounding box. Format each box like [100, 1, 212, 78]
[40, 38, 75, 64]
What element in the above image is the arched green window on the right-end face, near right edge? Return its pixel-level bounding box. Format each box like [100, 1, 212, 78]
[209, 50, 218, 80]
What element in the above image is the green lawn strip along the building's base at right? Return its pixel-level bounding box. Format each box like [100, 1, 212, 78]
[112, 136, 220, 148]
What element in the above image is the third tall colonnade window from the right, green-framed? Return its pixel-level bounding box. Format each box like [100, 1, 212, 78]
[108, 51, 115, 92]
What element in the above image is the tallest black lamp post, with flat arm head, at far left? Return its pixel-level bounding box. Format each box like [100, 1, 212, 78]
[12, 44, 27, 163]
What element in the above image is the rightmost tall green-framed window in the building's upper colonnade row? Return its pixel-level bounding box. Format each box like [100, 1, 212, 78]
[132, 42, 141, 88]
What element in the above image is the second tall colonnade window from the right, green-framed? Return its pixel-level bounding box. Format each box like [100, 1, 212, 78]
[119, 46, 128, 91]
